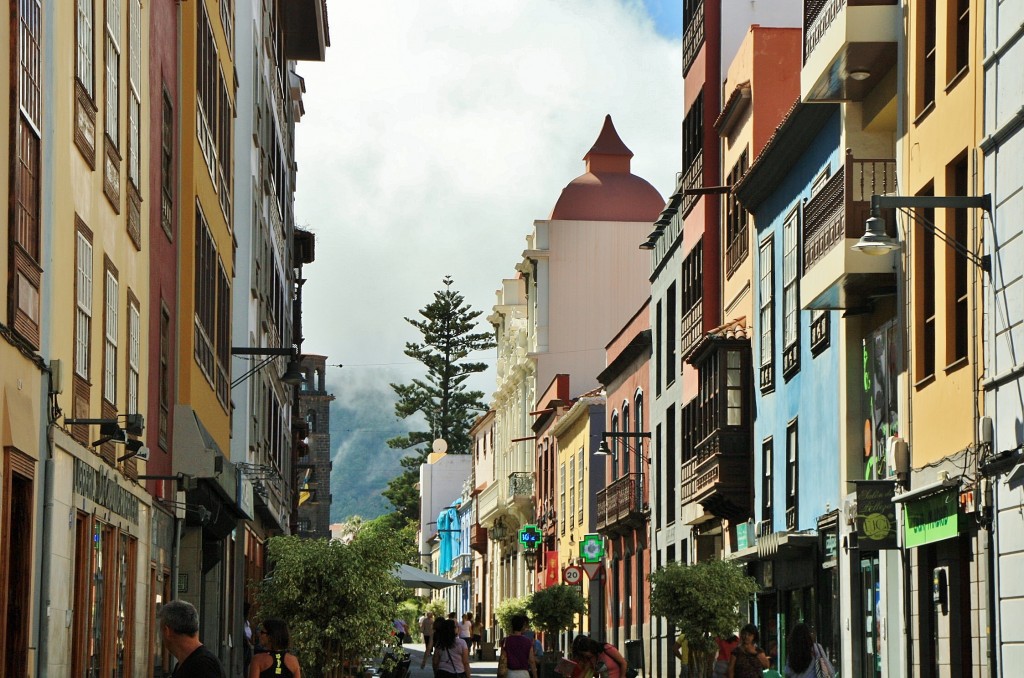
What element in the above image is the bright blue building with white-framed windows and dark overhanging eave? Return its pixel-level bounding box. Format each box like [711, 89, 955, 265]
[734, 102, 845, 665]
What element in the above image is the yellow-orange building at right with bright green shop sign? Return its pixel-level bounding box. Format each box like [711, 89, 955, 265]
[897, 0, 988, 676]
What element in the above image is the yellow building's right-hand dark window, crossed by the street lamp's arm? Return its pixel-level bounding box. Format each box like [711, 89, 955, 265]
[945, 154, 971, 365]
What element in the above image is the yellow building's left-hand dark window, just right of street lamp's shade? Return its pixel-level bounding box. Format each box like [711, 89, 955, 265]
[913, 184, 939, 382]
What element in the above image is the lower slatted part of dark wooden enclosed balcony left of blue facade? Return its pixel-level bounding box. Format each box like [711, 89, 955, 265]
[680, 429, 754, 522]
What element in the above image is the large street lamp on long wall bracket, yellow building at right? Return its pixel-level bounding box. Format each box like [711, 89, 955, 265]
[853, 194, 992, 273]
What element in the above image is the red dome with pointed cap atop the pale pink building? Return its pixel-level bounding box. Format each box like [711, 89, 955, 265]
[551, 116, 665, 221]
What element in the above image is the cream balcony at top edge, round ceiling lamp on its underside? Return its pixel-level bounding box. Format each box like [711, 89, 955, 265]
[800, 0, 903, 102]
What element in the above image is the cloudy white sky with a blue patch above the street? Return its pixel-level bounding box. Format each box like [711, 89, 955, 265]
[295, 0, 683, 464]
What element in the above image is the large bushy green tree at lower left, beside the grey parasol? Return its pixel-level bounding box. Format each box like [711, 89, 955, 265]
[253, 531, 409, 678]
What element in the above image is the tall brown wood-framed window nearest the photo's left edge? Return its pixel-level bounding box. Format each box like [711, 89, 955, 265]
[7, 0, 43, 347]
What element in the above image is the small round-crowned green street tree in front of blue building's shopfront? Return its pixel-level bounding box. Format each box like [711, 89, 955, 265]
[648, 560, 760, 676]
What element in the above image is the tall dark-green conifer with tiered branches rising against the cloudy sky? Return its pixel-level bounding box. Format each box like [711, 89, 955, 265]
[383, 276, 496, 520]
